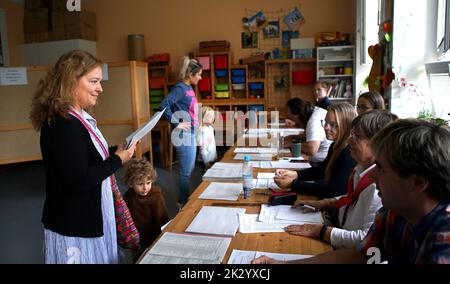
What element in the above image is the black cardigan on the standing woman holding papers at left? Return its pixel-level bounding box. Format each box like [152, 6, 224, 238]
[40, 115, 122, 238]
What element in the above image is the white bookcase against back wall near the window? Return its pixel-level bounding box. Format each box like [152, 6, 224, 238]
[317, 45, 357, 105]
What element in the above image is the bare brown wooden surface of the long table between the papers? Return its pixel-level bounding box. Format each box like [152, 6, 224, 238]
[139, 147, 331, 263]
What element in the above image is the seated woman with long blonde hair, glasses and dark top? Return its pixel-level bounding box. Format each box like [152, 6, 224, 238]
[275, 103, 356, 198]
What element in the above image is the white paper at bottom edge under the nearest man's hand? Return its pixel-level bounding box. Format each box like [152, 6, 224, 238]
[228, 249, 312, 264]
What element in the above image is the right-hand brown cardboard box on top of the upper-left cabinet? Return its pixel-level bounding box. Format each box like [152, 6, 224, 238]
[64, 11, 97, 41]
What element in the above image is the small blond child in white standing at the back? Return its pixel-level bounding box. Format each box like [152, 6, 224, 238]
[197, 106, 217, 169]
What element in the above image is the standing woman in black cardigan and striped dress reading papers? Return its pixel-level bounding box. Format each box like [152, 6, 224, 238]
[30, 50, 136, 263]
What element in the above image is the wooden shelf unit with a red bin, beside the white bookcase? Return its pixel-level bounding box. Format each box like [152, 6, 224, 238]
[265, 58, 316, 117]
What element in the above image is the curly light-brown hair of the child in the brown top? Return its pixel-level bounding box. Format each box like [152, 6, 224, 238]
[124, 158, 158, 187]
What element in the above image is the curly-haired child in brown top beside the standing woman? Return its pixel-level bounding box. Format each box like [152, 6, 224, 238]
[123, 158, 168, 254]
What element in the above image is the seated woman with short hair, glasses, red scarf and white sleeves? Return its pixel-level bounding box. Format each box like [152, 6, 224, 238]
[285, 110, 397, 248]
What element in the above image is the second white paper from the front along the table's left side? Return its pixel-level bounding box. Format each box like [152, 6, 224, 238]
[186, 206, 245, 236]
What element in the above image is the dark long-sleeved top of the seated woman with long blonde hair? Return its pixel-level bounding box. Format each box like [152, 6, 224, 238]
[292, 142, 357, 198]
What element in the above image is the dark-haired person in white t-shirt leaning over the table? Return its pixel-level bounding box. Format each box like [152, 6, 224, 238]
[285, 98, 331, 166]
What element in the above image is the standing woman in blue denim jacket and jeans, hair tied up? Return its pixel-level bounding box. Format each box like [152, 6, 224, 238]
[160, 57, 203, 206]
